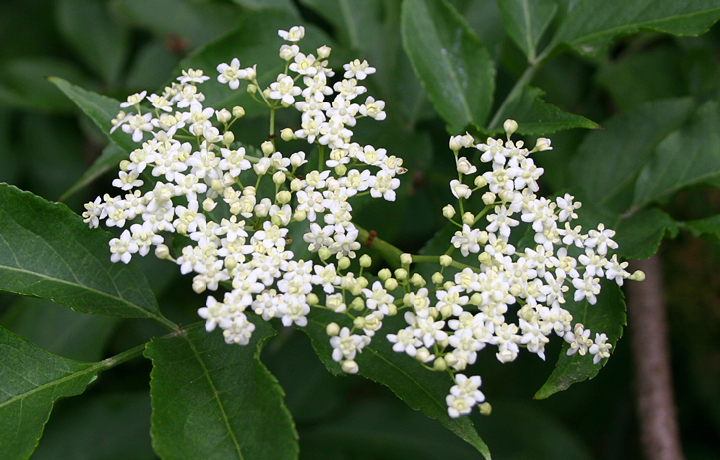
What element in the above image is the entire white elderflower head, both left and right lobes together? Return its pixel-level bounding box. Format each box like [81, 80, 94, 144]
[83, 27, 642, 417]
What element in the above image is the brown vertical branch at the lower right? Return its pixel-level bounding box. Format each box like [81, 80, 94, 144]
[628, 254, 685, 460]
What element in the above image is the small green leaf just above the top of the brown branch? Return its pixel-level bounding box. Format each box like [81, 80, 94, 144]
[614, 207, 678, 259]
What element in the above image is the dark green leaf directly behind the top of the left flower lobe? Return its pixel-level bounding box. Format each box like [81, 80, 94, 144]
[178, 10, 329, 117]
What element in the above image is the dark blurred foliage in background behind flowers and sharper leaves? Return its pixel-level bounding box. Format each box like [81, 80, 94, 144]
[0, 0, 720, 460]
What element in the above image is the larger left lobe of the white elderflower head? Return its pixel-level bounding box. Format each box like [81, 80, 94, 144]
[83, 27, 405, 356]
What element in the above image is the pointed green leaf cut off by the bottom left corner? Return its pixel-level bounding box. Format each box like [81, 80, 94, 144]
[0, 327, 102, 460]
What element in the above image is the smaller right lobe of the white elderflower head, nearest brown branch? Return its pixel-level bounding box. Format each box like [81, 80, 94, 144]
[387, 120, 642, 417]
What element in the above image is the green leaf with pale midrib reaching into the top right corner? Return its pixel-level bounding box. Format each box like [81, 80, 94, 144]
[547, 0, 720, 54]
